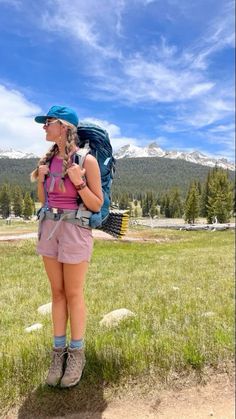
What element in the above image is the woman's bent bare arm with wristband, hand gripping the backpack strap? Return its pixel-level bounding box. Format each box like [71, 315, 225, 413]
[67, 154, 103, 212]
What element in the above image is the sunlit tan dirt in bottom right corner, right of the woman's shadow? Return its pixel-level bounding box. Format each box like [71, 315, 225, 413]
[101, 378, 235, 419]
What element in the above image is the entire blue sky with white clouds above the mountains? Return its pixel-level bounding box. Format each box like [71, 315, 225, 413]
[0, 0, 235, 160]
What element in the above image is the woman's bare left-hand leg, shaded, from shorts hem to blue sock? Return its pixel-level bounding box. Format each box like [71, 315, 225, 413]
[43, 256, 68, 336]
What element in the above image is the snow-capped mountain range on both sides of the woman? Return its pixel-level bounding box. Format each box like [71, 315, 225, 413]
[0, 142, 235, 171]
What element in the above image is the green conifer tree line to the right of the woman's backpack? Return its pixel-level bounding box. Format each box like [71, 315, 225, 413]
[113, 167, 235, 223]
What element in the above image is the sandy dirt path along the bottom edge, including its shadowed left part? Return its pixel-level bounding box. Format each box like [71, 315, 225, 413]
[4, 374, 235, 419]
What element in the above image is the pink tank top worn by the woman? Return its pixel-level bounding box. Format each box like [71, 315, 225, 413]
[46, 156, 78, 210]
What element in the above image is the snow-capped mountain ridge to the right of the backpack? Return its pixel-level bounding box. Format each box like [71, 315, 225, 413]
[115, 143, 235, 170]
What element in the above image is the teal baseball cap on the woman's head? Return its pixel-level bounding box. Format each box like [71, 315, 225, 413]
[34, 105, 79, 127]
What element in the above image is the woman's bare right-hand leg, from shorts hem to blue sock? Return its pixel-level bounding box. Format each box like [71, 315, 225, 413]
[63, 261, 88, 340]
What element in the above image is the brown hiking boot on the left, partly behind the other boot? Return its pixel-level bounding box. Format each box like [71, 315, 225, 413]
[46, 348, 67, 387]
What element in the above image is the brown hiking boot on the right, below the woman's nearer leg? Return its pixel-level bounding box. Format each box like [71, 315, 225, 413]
[61, 348, 85, 387]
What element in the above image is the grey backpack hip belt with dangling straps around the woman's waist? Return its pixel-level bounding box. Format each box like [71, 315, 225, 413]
[38, 208, 91, 240]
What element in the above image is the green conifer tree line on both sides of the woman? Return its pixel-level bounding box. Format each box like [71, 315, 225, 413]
[0, 167, 235, 223]
